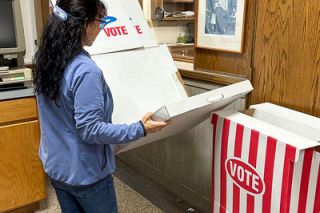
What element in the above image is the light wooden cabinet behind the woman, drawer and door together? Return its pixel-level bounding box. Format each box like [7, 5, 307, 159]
[0, 98, 45, 212]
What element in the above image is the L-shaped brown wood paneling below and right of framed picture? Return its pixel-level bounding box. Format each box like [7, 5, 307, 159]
[195, 0, 256, 79]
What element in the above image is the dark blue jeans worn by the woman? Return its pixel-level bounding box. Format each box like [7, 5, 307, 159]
[51, 175, 118, 213]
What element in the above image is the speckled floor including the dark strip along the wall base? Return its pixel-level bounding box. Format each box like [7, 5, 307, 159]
[35, 159, 200, 213]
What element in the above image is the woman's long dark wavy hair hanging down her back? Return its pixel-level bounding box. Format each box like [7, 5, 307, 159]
[33, 0, 106, 103]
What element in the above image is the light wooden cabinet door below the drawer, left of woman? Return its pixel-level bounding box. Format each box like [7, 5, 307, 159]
[0, 120, 45, 212]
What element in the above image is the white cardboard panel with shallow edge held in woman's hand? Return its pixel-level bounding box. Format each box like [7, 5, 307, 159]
[117, 80, 253, 153]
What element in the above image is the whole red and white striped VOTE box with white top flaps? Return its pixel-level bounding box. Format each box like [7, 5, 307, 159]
[212, 104, 320, 213]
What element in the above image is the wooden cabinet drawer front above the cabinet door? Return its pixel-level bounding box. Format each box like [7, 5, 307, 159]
[0, 97, 38, 125]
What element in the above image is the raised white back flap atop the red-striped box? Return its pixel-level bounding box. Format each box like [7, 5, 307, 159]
[250, 103, 320, 142]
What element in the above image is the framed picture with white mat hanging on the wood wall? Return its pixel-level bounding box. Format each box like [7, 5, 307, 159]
[195, 0, 246, 53]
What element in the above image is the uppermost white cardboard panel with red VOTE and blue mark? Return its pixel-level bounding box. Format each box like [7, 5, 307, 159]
[85, 0, 143, 55]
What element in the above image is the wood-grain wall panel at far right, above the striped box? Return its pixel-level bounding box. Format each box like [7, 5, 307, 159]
[250, 0, 320, 116]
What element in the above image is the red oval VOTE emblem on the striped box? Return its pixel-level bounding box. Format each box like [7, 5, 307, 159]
[225, 157, 265, 195]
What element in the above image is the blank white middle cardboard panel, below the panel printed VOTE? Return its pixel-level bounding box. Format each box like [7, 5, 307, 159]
[92, 46, 188, 123]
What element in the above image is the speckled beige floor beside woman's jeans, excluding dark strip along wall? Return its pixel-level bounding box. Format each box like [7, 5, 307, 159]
[36, 177, 163, 213]
